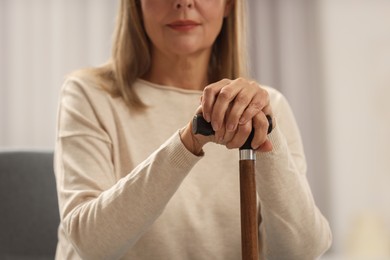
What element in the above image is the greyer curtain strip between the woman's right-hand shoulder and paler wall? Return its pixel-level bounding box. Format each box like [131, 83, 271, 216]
[248, 0, 332, 247]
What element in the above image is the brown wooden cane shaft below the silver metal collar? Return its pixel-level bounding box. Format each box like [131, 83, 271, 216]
[240, 160, 259, 260]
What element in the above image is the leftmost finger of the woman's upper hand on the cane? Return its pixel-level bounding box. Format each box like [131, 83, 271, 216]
[201, 79, 231, 122]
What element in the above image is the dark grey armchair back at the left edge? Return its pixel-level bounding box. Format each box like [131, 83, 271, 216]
[0, 151, 59, 260]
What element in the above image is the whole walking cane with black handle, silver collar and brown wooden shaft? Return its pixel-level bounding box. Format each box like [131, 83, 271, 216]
[192, 114, 272, 260]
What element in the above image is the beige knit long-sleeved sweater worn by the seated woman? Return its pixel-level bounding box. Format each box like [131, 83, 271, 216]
[55, 77, 331, 260]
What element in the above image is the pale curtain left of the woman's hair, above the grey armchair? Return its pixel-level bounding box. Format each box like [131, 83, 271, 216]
[0, 0, 116, 149]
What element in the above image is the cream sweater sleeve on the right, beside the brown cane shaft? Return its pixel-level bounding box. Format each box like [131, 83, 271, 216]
[256, 90, 332, 260]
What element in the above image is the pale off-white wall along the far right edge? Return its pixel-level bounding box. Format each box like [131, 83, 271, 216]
[317, 0, 390, 259]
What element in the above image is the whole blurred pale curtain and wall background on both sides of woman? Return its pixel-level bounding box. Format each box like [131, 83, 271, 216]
[0, 0, 390, 260]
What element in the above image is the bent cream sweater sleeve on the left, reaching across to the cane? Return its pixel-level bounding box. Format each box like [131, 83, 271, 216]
[55, 79, 199, 259]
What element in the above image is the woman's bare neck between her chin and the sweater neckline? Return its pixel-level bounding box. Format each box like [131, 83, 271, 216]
[143, 48, 210, 90]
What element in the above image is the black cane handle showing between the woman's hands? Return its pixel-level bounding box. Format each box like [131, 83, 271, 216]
[192, 114, 273, 150]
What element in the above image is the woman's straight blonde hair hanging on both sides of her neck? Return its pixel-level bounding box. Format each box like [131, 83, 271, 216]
[92, 0, 247, 110]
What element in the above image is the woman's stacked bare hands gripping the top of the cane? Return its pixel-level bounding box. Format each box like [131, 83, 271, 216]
[201, 78, 272, 152]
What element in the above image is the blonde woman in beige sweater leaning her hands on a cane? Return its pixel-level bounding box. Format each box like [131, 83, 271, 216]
[55, 0, 331, 259]
